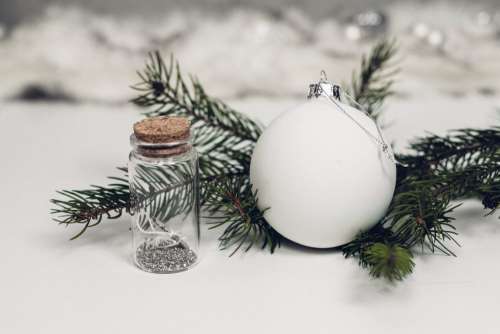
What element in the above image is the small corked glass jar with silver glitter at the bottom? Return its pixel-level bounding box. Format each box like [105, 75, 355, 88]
[128, 117, 200, 273]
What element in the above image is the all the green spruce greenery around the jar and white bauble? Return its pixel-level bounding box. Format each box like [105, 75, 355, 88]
[52, 41, 500, 281]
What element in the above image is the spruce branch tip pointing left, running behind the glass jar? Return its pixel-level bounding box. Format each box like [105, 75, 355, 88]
[51, 168, 248, 240]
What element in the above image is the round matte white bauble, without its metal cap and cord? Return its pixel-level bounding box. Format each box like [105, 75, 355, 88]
[250, 96, 396, 248]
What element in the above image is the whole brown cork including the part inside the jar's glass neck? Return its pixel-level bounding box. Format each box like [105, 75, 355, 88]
[131, 116, 191, 158]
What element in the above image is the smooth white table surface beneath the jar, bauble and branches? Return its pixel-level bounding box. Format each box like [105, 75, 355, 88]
[0, 97, 500, 334]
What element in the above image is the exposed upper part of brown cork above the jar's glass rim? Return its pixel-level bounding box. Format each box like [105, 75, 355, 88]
[134, 116, 191, 143]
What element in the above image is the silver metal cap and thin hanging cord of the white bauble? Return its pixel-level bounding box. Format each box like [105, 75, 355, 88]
[307, 70, 406, 166]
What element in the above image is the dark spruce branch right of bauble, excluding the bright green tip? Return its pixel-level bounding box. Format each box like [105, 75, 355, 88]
[342, 127, 500, 276]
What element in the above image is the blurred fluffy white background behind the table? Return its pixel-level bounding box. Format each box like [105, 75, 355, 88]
[0, 0, 500, 103]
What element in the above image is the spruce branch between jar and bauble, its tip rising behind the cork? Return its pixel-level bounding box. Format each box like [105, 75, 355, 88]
[129, 52, 279, 253]
